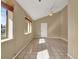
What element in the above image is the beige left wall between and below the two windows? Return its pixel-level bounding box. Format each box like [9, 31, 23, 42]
[1, 2, 33, 59]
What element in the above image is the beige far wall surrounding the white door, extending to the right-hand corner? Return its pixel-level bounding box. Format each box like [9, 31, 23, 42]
[34, 7, 68, 40]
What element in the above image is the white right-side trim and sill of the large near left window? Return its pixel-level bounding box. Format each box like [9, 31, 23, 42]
[1, 11, 13, 43]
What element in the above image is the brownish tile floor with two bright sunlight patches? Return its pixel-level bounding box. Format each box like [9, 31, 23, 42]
[16, 38, 68, 59]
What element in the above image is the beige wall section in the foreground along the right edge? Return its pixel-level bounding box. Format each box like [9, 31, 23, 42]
[68, 0, 78, 59]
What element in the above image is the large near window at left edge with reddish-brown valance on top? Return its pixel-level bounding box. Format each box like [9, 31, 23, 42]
[1, 1, 13, 42]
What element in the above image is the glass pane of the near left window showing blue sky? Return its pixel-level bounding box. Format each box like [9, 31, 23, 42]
[1, 7, 7, 39]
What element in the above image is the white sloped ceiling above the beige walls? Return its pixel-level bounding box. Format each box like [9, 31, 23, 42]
[16, 0, 68, 20]
